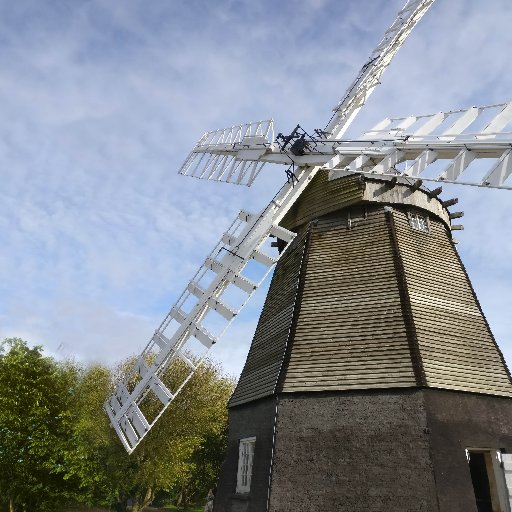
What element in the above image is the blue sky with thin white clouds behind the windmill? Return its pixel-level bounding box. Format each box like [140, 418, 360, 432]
[0, 0, 512, 375]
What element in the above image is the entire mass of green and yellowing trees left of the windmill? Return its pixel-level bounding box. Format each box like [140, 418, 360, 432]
[0, 338, 233, 512]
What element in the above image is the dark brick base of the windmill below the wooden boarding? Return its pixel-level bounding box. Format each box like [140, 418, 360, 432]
[215, 389, 512, 512]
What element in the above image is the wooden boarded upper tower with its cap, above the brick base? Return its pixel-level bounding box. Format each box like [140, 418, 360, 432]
[230, 176, 512, 406]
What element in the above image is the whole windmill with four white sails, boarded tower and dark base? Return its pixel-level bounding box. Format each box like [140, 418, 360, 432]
[105, 0, 512, 510]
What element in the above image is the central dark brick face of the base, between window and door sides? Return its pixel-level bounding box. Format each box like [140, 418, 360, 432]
[268, 390, 438, 512]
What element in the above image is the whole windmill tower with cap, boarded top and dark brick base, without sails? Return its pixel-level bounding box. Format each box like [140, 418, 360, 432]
[215, 172, 512, 512]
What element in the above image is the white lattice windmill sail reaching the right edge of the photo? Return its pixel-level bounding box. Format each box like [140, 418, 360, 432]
[326, 102, 512, 189]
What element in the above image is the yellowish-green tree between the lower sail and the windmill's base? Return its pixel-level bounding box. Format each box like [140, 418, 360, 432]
[115, 361, 234, 512]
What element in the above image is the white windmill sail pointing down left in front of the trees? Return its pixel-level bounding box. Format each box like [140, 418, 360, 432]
[104, 170, 311, 453]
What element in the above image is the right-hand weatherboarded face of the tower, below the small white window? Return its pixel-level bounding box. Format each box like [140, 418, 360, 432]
[393, 209, 512, 396]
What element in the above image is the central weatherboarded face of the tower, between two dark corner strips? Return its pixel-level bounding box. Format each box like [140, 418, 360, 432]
[282, 207, 416, 392]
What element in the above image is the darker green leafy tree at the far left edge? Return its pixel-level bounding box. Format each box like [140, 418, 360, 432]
[0, 338, 77, 512]
